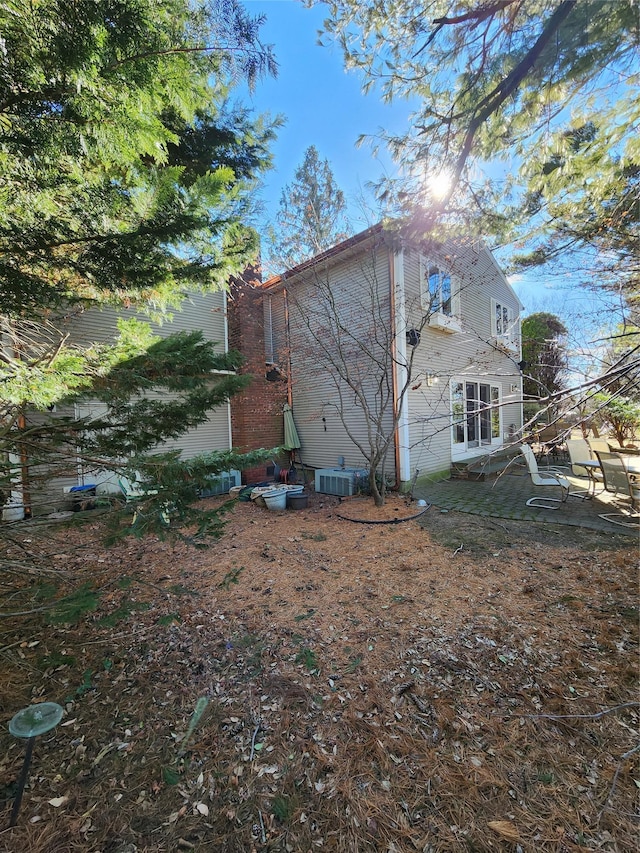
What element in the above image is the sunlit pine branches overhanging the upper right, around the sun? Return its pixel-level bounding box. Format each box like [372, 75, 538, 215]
[324, 0, 640, 402]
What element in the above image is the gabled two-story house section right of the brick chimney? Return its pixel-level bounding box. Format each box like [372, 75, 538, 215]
[264, 225, 522, 485]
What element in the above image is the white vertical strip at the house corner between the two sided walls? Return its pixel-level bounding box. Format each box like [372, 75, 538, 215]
[391, 249, 411, 483]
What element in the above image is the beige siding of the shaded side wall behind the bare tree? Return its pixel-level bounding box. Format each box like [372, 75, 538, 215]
[288, 241, 395, 476]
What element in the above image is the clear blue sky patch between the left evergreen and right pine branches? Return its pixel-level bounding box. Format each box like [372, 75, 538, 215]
[243, 0, 410, 230]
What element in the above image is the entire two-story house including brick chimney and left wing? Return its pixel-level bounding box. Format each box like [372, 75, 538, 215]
[2, 225, 522, 513]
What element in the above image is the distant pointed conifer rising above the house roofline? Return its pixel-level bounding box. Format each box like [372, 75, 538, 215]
[268, 145, 349, 272]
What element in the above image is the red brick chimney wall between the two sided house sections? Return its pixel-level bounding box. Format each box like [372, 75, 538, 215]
[227, 269, 287, 483]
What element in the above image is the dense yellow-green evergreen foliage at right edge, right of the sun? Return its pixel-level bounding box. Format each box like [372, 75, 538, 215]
[514, 111, 640, 312]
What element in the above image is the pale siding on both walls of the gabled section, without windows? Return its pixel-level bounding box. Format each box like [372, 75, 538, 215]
[264, 230, 522, 482]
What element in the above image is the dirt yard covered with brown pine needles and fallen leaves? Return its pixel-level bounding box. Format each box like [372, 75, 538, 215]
[0, 496, 640, 853]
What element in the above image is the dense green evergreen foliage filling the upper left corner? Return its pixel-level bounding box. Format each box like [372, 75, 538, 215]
[0, 0, 272, 314]
